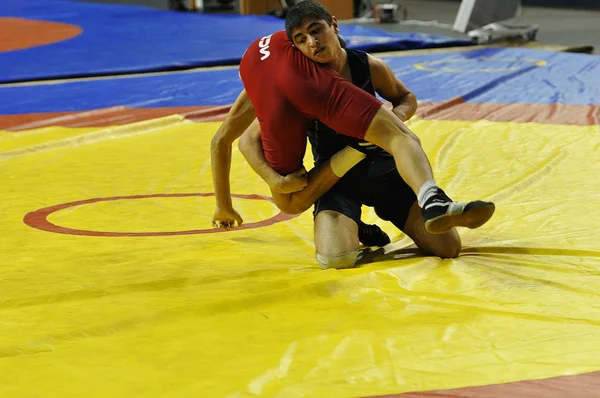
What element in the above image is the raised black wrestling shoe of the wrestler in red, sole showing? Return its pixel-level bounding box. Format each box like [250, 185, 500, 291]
[421, 188, 496, 234]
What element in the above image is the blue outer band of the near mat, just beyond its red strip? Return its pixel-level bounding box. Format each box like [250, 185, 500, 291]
[0, 48, 600, 115]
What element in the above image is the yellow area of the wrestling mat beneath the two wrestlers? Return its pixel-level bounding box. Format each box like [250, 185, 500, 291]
[0, 117, 600, 398]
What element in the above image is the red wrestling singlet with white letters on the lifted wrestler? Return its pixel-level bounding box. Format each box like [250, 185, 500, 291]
[240, 31, 382, 175]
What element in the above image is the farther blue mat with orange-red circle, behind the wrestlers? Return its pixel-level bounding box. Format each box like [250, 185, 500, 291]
[0, 0, 472, 83]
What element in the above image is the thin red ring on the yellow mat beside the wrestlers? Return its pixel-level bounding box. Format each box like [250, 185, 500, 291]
[23, 192, 298, 237]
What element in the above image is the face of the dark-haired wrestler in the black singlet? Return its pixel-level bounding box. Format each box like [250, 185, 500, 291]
[292, 17, 341, 64]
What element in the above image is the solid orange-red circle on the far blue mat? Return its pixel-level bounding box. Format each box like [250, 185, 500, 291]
[0, 17, 83, 52]
